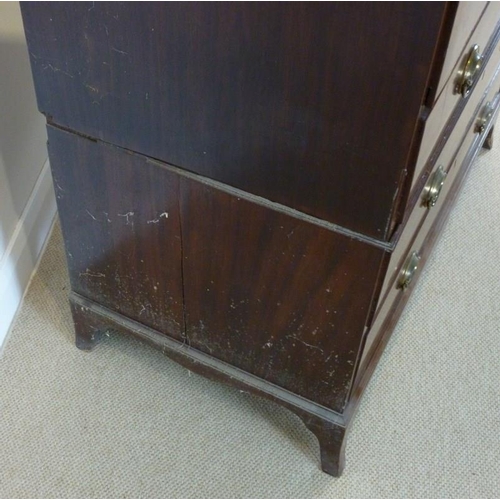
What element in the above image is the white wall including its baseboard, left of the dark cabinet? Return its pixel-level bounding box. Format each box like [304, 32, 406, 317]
[0, 2, 55, 346]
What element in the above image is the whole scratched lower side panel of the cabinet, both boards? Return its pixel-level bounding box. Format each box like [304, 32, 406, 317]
[48, 126, 385, 411]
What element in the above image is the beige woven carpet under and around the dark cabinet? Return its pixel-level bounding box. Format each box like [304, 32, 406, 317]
[0, 139, 500, 498]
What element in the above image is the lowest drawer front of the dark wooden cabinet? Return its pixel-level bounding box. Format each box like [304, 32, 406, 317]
[359, 85, 500, 373]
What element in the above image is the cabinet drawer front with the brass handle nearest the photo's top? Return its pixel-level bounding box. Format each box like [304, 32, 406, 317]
[412, 2, 500, 187]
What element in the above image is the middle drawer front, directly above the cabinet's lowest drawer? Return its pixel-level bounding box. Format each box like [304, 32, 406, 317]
[376, 65, 500, 316]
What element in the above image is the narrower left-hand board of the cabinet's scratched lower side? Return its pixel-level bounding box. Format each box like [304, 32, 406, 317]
[48, 126, 184, 339]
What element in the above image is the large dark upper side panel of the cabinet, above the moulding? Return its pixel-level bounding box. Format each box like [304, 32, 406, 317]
[22, 2, 445, 240]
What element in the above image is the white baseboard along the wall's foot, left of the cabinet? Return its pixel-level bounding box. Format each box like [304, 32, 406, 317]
[0, 160, 56, 347]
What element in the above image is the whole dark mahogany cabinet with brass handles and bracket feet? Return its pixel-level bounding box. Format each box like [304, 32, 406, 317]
[22, 2, 500, 475]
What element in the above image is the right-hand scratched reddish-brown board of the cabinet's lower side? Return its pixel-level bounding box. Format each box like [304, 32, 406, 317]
[180, 178, 385, 411]
